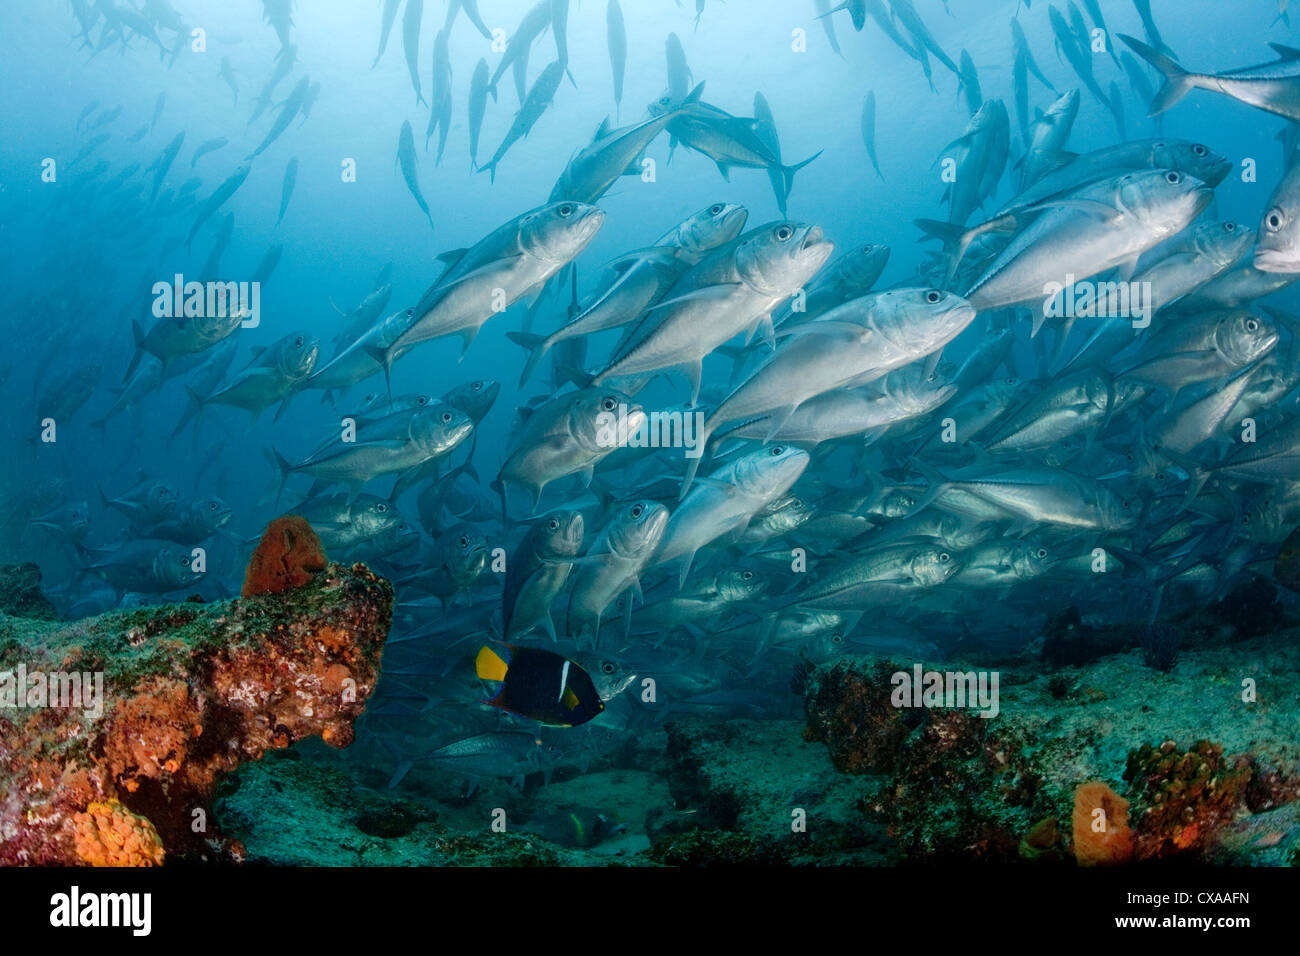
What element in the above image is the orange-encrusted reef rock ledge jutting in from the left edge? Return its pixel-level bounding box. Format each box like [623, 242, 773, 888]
[0, 564, 393, 865]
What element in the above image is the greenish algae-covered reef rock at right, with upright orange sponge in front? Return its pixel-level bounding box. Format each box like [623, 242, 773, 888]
[802, 631, 1300, 865]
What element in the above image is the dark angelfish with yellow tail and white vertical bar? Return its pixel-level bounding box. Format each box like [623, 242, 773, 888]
[475, 644, 605, 727]
